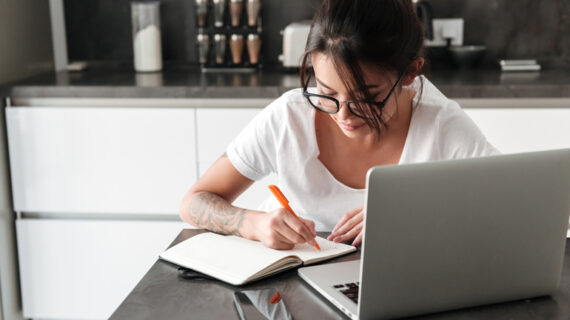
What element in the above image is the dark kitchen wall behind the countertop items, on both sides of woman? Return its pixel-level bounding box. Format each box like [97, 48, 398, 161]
[65, 0, 570, 66]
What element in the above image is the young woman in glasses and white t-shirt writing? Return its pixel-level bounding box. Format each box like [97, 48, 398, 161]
[180, 0, 498, 249]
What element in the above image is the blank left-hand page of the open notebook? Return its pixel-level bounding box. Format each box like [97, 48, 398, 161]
[160, 232, 296, 284]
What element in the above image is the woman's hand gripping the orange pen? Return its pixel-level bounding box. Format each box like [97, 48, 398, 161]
[255, 208, 317, 250]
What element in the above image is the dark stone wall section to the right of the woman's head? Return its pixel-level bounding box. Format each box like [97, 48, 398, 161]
[429, 0, 570, 67]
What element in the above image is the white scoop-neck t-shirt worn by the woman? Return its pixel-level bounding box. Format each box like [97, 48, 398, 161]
[227, 76, 499, 231]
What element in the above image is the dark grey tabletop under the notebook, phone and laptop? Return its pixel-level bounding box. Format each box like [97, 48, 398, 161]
[111, 229, 570, 320]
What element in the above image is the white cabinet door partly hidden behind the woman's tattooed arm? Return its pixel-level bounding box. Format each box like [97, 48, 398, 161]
[196, 108, 277, 209]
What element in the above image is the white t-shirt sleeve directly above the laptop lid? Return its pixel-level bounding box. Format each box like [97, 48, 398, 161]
[438, 102, 501, 159]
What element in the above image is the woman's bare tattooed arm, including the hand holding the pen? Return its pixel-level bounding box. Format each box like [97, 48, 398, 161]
[180, 154, 316, 249]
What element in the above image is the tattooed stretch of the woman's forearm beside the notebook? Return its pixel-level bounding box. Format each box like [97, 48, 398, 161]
[190, 192, 246, 236]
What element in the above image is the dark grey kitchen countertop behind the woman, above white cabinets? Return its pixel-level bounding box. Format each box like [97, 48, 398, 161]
[0, 66, 570, 99]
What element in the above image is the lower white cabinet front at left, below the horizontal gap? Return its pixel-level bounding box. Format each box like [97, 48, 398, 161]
[16, 219, 183, 319]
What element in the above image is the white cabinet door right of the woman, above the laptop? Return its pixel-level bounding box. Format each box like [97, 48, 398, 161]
[464, 106, 570, 153]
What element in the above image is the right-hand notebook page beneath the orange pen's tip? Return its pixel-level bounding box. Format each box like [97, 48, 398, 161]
[287, 237, 356, 264]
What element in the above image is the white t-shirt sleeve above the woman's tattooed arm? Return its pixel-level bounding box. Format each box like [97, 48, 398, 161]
[226, 98, 286, 180]
